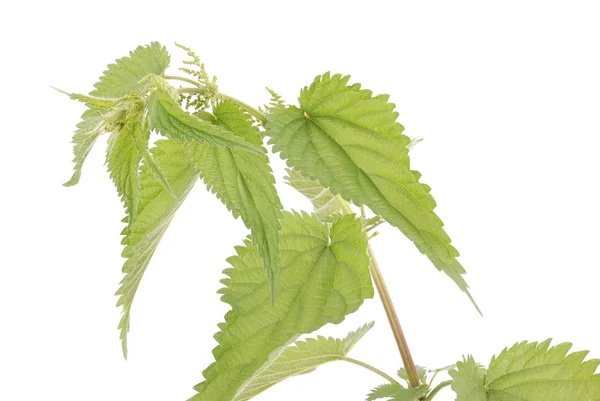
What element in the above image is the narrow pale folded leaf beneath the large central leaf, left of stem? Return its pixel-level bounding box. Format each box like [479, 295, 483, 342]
[229, 322, 373, 401]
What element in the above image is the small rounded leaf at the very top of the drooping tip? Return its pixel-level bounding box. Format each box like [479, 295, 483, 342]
[90, 42, 170, 98]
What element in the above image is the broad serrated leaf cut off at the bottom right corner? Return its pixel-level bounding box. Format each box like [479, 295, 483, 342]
[451, 340, 600, 401]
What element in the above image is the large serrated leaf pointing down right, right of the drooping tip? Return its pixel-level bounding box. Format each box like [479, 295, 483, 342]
[267, 73, 475, 310]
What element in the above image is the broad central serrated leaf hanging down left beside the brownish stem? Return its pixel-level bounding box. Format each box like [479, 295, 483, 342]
[192, 212, 373, 401]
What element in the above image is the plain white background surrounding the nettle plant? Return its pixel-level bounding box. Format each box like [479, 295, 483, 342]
[0, 0, 600, 401]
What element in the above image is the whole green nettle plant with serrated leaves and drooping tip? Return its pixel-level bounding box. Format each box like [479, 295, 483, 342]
[58, 43, 600, 401]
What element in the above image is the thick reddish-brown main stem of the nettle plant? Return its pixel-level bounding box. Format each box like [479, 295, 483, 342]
[336, 195, 419, 387]
